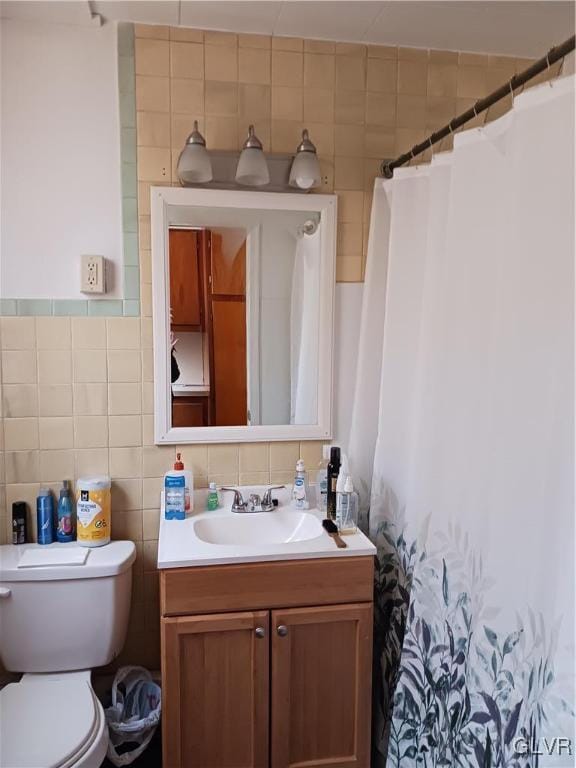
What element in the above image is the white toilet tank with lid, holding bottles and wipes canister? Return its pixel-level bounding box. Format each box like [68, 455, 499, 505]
[0, 541, 136, 672]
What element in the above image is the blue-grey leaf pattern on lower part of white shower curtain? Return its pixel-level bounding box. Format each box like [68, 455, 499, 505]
[371, 490, 574, 768]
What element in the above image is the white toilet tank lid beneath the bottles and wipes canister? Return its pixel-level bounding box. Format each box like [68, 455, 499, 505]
[0, 541, 136, 582]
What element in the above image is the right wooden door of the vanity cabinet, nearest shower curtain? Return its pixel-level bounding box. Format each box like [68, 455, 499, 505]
[270, 603, 372, 768]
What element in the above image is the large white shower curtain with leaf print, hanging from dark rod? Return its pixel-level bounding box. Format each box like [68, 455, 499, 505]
[349, 77, 576, 768]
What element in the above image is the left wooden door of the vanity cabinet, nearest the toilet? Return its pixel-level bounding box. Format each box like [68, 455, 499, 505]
[162, 611, 270, 768]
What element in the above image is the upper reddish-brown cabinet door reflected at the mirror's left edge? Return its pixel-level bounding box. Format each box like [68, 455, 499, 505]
[169, 229, 202, 331]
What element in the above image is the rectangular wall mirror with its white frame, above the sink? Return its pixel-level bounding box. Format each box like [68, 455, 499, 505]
[151, 187, 336, 444]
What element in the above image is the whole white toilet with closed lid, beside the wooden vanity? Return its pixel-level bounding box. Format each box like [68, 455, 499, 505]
[0, 541, 136, 768]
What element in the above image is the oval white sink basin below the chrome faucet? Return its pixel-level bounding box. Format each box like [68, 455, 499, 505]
[194, 510, 323, 547]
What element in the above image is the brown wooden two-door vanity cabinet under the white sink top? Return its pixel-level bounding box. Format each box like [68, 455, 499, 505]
[160, 557, 373, 768]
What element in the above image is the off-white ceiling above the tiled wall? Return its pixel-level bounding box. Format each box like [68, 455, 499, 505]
[0, 0, 575, 57]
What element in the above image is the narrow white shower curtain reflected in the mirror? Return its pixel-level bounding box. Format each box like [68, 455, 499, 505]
[290, 228, 320, 424]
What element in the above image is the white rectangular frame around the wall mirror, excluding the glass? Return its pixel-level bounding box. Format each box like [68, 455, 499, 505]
[150, 187, 337, 445]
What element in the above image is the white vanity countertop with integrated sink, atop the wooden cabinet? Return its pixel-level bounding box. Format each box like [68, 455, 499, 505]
[158, 486, 376, 568]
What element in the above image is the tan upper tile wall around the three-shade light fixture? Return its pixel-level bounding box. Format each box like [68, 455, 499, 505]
[136, 25, 544, 288]
